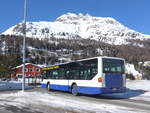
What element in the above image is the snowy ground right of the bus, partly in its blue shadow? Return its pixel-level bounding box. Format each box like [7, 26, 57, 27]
[101, 80, 150, 101]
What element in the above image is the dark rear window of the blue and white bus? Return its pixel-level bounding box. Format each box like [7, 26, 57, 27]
[103, 58, 125, 74]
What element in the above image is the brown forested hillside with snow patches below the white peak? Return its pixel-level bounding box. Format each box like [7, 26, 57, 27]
[0, 35, 150, 78]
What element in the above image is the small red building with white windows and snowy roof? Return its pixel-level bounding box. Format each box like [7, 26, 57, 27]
[11, 63, 42, 78]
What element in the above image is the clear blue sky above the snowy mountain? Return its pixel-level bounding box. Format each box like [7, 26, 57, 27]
[0, 0, 150, 35]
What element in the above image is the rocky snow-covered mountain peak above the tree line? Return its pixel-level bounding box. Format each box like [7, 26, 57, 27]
[2, 13, 150, 45]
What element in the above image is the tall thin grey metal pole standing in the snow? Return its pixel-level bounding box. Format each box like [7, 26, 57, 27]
[22, 0, 27, 92]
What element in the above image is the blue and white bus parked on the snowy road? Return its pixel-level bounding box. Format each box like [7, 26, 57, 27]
[41, 56, 126, 95]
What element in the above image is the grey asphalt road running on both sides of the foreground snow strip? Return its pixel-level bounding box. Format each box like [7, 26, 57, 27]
[0, 88, 150, 113]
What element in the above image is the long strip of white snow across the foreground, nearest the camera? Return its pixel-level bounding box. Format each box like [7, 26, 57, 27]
[0, 92, 140, 113]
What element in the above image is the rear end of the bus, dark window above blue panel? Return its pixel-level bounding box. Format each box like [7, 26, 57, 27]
[101, 58, 126, 93]
